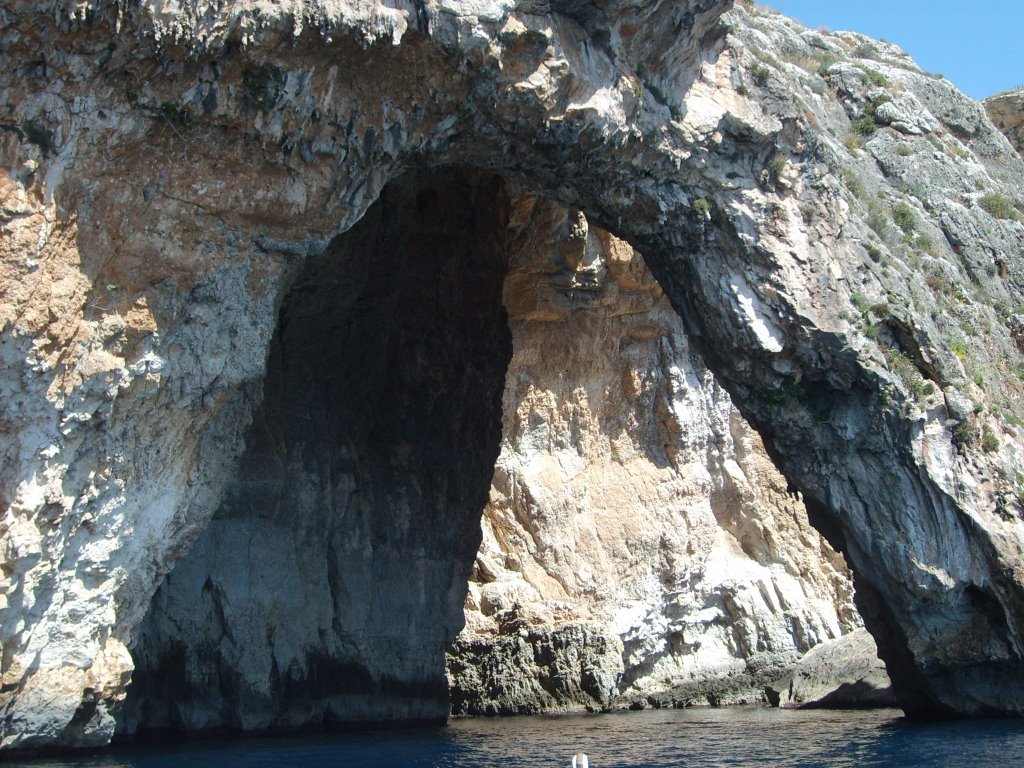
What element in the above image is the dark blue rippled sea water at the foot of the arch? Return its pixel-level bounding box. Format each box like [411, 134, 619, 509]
[12, 708, 1024, 768]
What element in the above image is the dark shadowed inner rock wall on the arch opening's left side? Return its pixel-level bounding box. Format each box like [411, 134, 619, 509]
[119, 168, 511, 734]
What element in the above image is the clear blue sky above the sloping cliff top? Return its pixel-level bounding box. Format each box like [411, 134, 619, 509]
[763, 0, 1024, 98]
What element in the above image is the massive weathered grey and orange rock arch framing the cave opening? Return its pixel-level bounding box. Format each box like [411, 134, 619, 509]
[0, 0, 1024, 749]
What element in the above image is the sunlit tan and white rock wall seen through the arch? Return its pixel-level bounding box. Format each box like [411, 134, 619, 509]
[449, 198, 860, 714]
